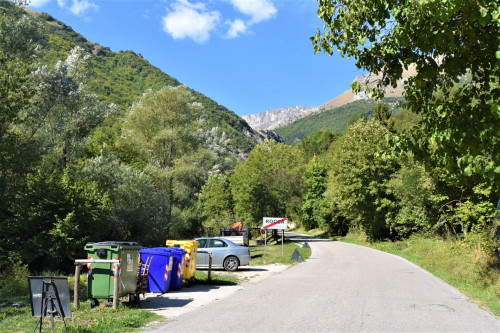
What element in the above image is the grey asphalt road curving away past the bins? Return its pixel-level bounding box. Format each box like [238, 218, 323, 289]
[148, 232, 500, 332]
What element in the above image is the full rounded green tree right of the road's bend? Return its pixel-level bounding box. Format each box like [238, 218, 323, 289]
[325, 121, 398, 239]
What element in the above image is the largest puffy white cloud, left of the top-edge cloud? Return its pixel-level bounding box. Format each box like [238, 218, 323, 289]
[163, 0, 220, 43]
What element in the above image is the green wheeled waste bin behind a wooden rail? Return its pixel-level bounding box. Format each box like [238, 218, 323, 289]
[85, 242, 142, 307]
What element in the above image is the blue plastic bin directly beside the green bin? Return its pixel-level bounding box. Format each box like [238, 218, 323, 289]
[139, 247, 174, 293]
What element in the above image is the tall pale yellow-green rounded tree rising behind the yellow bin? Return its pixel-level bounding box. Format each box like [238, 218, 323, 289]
[117, 86, 206, 238]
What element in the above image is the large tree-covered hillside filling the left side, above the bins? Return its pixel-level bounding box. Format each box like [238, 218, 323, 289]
[0, 0, 250, 274]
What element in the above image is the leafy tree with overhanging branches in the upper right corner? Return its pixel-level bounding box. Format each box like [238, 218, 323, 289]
[311, 0, 500, 192]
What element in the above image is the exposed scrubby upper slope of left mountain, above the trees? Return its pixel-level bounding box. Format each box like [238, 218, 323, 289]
[25, 9, 267, 157]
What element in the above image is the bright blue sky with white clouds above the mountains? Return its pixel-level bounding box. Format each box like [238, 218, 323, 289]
[29, 0, 364, 116]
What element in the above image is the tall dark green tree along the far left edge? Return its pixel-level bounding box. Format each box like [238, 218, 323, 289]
[0, 1, 44, 182]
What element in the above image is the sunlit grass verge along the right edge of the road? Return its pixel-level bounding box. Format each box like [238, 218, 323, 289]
[338, 233, 500, 316]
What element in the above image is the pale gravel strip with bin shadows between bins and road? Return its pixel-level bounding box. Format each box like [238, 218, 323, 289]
[141, 264, 289, 320]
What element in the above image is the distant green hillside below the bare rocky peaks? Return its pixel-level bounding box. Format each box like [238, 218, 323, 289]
[273, 98, 402, 145]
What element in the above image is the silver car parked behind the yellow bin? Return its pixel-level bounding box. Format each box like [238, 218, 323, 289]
[195, 237, 250, 271]
